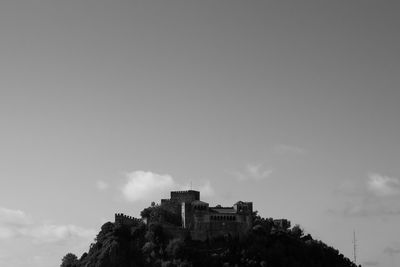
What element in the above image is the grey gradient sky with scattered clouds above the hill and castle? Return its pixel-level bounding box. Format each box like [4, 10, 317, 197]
[0, 0, 400, 267]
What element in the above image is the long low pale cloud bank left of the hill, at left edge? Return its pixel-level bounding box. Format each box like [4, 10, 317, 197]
[0, 207, 95, 243]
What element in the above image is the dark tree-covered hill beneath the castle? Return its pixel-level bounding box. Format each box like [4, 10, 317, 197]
[61, 210, 356, 267]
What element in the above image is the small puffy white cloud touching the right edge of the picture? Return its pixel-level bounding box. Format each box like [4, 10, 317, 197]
[367, 173, 400, 197]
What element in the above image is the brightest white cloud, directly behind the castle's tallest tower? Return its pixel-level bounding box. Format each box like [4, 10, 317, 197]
[121, 171, 214, 202]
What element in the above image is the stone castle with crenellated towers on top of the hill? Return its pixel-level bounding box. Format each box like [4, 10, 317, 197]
[115, 190, 253, 240]
